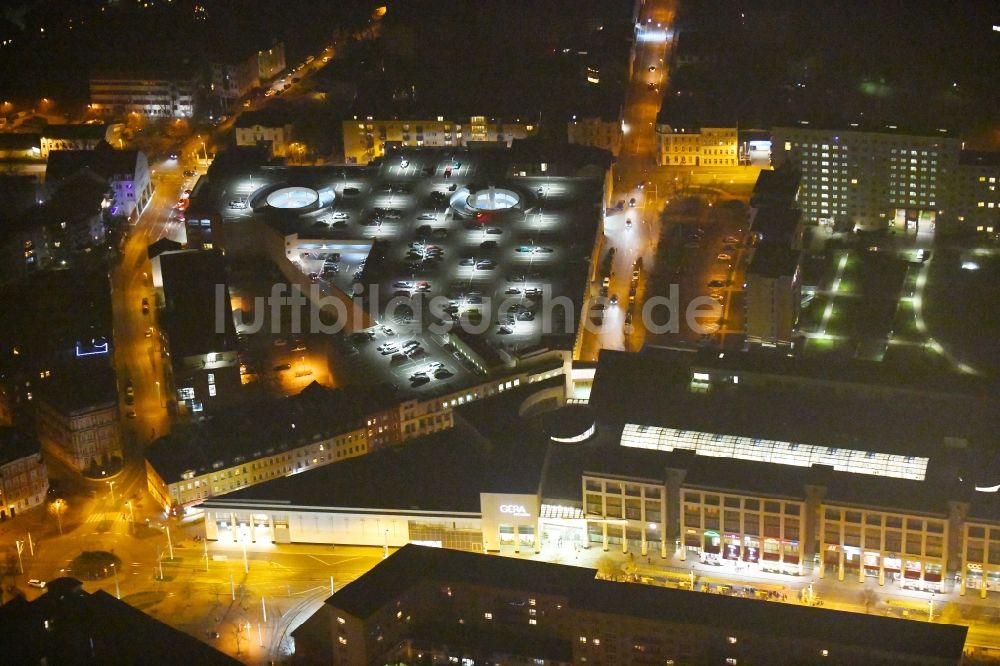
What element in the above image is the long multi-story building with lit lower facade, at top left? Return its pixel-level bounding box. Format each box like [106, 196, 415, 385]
[90, 76, 197, 118]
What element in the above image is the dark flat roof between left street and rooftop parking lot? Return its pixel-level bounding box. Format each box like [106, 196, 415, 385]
[159, 250, 236, 363]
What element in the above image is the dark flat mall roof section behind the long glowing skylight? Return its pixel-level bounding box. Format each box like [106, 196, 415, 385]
[590, 349, 1000, 457]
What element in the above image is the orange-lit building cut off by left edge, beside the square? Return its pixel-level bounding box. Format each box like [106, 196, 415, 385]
[0, 426, 49, 518]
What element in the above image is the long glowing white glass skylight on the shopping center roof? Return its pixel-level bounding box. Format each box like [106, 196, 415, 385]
[621, 423, 928, 481]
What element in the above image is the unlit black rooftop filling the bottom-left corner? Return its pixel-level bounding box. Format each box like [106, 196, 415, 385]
[0, 578, 240, 666]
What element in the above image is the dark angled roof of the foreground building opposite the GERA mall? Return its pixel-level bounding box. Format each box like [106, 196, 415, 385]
[326, 545, 968, 660]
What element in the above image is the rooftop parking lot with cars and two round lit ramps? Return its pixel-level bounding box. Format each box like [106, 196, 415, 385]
[195, 149, 602, 392]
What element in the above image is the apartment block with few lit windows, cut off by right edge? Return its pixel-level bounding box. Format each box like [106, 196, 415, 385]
[952, 150, 1000, 238]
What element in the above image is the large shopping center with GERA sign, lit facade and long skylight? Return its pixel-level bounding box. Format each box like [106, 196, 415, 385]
[197, 350, 1000, 595]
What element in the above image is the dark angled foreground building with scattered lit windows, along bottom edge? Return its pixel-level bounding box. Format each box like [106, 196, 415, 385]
[292, 545, 967, 666]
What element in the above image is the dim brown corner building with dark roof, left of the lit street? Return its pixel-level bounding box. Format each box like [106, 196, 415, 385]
[34, 375, 123, 475]
